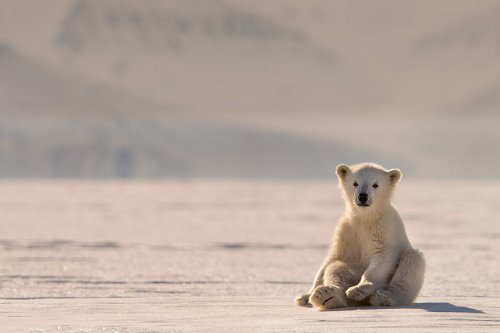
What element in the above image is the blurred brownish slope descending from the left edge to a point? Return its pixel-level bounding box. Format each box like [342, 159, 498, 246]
[0, 43, 158, 117]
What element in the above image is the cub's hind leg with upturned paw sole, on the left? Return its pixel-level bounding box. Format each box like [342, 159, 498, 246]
[309, 261, 361, 310]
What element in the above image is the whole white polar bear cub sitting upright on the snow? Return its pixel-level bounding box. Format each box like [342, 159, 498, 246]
[296, 163, 425, 310]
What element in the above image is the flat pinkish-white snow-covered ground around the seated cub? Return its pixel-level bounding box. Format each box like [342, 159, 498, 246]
[0, 179, 500, 333]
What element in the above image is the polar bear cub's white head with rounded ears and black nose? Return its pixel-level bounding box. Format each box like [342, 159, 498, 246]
[337, 163, 402, 211]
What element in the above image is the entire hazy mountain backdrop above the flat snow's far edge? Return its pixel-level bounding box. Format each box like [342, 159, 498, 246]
[0, 0, 500, 178]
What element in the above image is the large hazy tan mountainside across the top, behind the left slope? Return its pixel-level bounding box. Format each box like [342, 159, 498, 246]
[0, 0, 500, 116]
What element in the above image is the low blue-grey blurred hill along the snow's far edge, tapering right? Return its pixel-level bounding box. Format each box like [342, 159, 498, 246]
[0, 117, 394, 178]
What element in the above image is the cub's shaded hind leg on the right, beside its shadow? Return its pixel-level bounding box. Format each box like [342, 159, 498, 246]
[369, 250, 425, 306]
